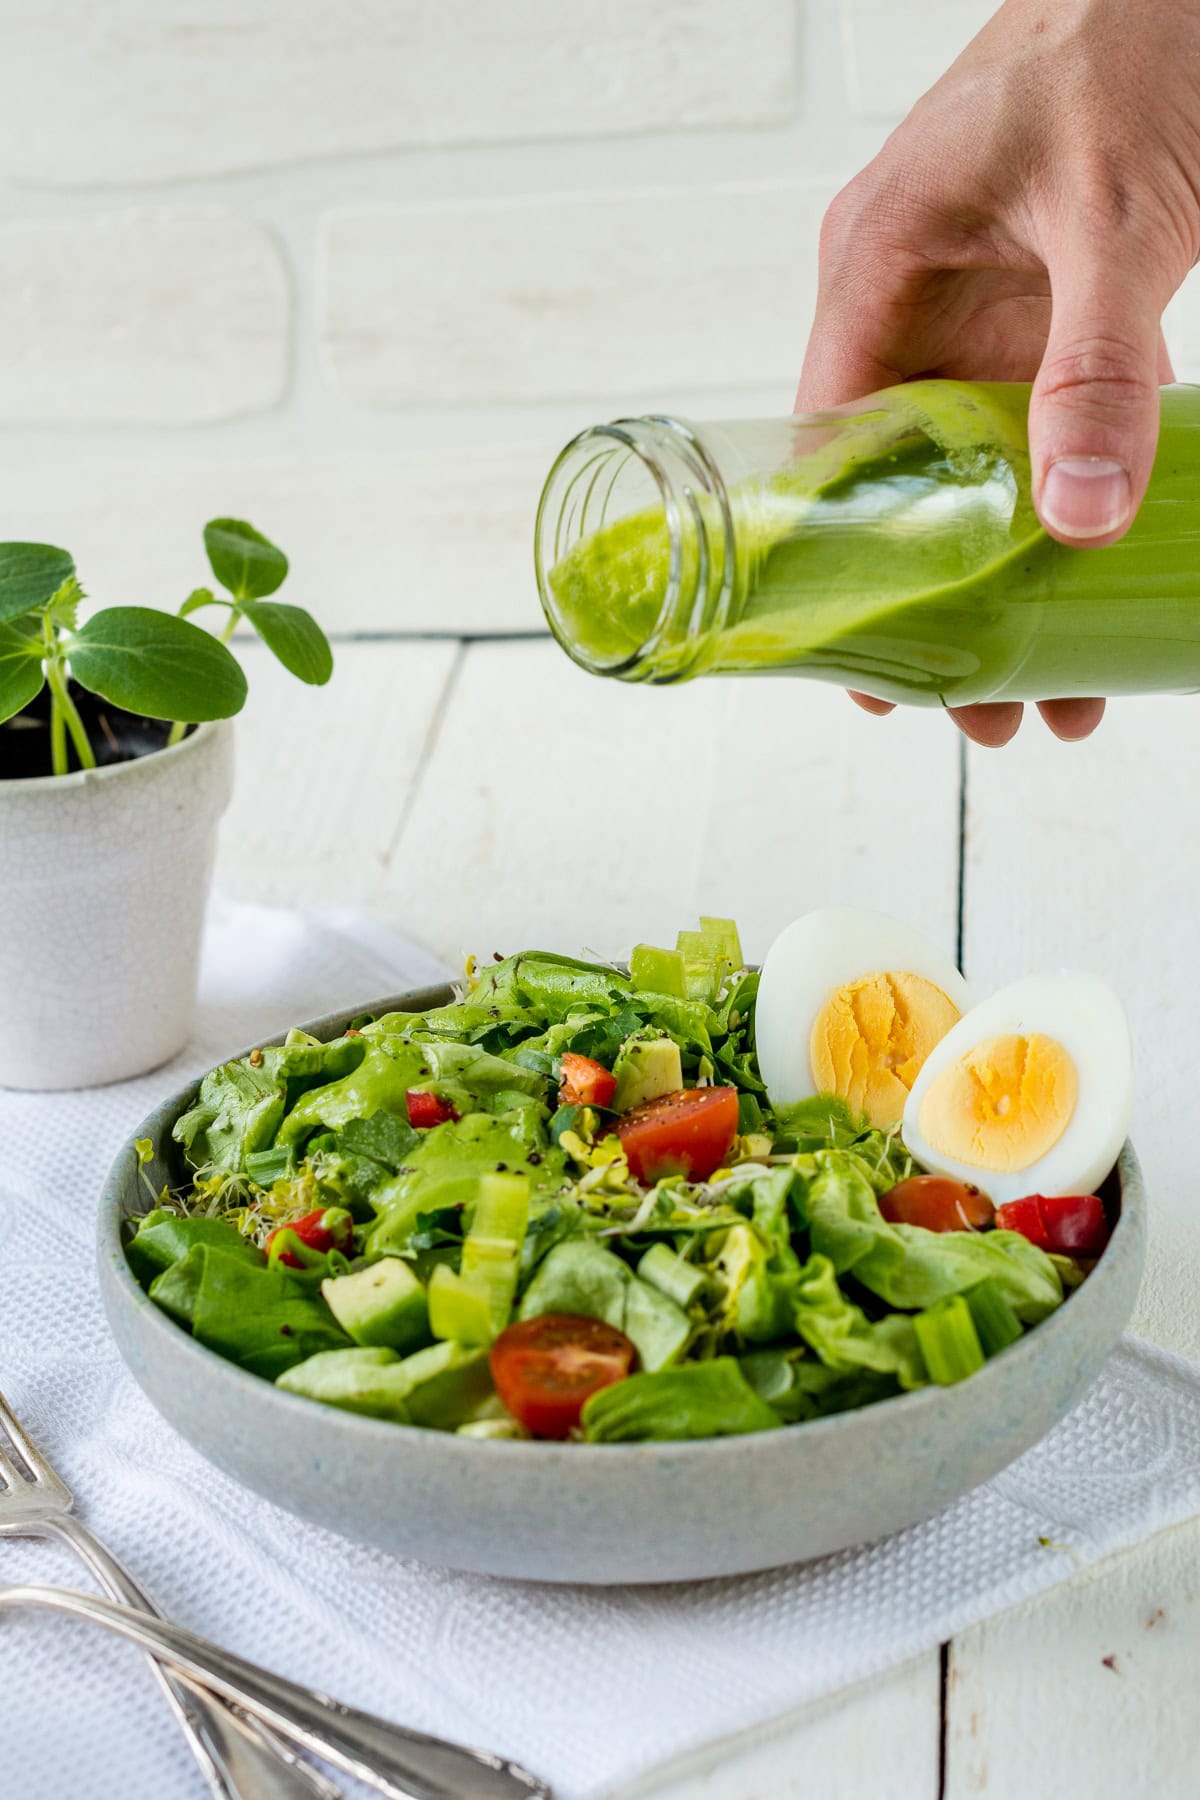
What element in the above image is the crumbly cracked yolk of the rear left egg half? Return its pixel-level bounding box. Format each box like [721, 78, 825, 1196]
[810, 968, 959, 1129]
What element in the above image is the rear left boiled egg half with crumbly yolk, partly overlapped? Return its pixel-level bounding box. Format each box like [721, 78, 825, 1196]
[754, 907, 968, 1130]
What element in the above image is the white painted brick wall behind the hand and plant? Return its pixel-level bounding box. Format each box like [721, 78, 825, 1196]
[0, 0, 1200, 632]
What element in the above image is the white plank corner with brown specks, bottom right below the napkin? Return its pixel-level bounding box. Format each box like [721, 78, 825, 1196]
[946, 1519, 1200, 1800]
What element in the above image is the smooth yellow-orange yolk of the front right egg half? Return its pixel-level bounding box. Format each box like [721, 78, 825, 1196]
[921, 1031, 1079, 1174]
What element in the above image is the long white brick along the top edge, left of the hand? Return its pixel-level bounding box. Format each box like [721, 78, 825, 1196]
[0, 0, 797, 185]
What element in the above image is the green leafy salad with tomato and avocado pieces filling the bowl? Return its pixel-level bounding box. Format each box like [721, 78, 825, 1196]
[128, 920, 1087, 1444]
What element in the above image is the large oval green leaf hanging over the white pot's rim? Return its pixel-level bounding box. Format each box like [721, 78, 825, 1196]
[67, 607, 246, 724]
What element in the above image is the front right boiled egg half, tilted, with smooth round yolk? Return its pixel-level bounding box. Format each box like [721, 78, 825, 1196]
[903, 972, 1133, 1206]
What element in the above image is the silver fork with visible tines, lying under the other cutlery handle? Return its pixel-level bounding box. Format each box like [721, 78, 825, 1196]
[0, 1393, 342, 1800]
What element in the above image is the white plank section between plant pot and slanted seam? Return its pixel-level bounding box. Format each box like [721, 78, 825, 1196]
[216, 643, 459, 907]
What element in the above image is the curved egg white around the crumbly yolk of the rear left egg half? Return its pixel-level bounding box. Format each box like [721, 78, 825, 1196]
[754, 907, 970, 1107]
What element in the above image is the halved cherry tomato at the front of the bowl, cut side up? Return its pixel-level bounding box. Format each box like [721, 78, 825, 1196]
[491, 1312, 637, 1438]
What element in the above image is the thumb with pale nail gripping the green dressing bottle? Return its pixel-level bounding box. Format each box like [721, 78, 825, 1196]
[1029, 252, 1162, 545]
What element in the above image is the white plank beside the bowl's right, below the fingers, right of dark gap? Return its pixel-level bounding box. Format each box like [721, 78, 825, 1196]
[966, 698, 1200, 1357]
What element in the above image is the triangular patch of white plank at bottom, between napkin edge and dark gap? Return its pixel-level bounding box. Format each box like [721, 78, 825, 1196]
[626, 1651, 941, 1800]
